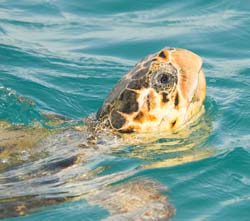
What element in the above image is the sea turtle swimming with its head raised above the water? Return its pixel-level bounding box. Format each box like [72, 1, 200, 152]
[0, 48, 206, 220]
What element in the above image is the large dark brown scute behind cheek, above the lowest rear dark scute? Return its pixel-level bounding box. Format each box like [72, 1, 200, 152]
[117, 90, 138, 114]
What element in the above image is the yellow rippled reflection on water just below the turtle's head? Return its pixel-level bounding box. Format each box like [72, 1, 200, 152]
[114, 104, 216, 168]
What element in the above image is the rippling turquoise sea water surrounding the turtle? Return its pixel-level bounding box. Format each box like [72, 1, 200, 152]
[0, 0, 250, 221]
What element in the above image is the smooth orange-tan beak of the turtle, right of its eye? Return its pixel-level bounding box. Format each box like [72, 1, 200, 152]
[172, 49, 206, 103]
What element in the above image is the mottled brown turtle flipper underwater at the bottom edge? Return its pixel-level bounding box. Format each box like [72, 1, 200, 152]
[88, 179, 175, 221]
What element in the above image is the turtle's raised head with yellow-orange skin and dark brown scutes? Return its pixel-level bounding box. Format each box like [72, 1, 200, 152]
[97, 48, 206, 133]
